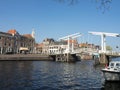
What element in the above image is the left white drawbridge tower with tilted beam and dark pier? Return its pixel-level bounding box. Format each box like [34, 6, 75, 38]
[51, 33, 81, 62]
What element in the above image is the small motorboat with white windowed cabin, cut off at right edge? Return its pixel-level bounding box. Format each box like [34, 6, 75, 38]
[102, 61, 120, 81]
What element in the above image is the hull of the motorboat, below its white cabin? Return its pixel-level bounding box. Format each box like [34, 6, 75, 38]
[102, 70, 120, 81]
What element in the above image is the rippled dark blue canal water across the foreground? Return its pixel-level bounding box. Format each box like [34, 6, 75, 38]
[0, 60, 120, 90]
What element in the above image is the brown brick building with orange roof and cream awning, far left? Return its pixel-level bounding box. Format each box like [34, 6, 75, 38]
[0, 29, 35, 54]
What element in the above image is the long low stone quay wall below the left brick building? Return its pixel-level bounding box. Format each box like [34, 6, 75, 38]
[0, 54, 53, 61]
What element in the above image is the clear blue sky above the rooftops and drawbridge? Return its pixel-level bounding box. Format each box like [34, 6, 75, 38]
[0, 0, 120, 50]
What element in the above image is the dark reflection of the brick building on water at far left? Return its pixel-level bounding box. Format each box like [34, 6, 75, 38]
[0, 61, 33, 90]
